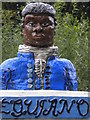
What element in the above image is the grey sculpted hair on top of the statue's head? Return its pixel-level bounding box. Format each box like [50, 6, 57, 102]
[21, 2, 57, 28]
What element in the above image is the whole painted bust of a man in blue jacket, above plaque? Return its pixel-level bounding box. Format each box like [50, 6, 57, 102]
[0, 2, 77, 90]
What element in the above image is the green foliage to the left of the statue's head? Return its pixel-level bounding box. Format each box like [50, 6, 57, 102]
[2, 10, 23, 61]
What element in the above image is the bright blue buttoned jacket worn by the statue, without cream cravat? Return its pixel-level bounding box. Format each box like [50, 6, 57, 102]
[0, 52, 77, 90]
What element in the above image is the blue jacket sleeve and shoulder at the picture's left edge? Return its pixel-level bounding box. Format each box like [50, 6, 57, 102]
[0, 58, 18, 90]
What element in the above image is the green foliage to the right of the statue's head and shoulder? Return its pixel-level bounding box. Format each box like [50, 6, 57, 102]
[54, 3, 89, 91]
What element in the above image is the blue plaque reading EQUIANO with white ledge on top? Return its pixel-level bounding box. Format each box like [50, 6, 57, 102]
[0, 90, 90, 119]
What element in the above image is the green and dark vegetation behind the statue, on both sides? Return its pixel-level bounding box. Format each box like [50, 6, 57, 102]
[2, 2, 90, 91]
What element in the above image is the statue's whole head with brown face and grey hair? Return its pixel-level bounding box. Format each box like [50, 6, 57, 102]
[21, 2, 56, 47]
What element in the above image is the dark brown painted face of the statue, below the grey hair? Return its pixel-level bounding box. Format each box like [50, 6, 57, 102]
[22, 14, 55, 47]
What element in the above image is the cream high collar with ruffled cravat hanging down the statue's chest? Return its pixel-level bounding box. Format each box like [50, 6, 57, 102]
[18, 44, 58, 78]
